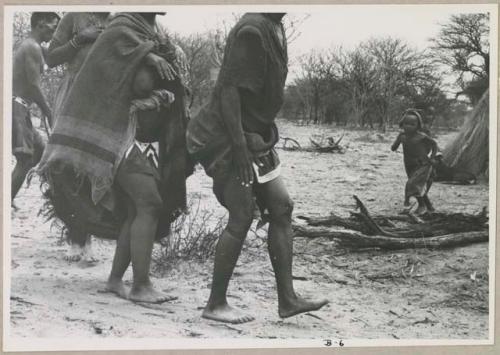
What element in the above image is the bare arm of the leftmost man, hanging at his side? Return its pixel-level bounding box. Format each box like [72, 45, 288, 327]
[24, 45, 52, 127]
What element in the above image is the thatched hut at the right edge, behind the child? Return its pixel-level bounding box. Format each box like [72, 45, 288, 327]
[443, 90, 489, 177]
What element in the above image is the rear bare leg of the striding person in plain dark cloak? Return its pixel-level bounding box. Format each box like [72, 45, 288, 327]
[202, 177, 254, 323]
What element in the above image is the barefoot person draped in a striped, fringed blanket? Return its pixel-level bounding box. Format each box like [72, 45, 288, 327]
[39, 13, 188, 303]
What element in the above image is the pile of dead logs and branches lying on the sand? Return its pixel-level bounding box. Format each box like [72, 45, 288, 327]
[293, 196, 488, 250]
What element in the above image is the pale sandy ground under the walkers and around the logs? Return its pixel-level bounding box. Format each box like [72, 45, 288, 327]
[10, 122, 488, 339]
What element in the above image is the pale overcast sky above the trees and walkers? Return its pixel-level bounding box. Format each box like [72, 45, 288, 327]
[161, 5, 492, 84]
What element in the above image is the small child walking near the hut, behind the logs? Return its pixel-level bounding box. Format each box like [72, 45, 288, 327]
[391, 109, 438, 214]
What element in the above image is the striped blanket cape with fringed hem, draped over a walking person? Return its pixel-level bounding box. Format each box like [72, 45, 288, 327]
[38, 13, 188, 238]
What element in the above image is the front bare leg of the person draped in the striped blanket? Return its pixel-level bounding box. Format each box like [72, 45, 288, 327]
[112, 172, 172, 303]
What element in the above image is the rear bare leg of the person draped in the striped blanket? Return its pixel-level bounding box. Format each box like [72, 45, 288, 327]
[106, 201, 135, 298]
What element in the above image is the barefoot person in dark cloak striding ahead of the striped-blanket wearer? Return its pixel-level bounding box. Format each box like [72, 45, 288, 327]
[187, 13, 327, 323]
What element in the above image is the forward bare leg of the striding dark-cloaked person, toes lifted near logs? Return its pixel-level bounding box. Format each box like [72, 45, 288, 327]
[258, 177, 328, 318]
